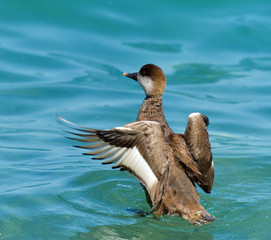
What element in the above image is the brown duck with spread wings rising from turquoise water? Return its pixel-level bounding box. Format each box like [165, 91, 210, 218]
[58, 64, 216, 225]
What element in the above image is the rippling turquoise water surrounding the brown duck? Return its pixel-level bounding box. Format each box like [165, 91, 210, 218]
[0, 0, 271, 240]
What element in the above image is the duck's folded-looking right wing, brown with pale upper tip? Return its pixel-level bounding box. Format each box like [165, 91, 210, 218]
[184, 113, 214, 193]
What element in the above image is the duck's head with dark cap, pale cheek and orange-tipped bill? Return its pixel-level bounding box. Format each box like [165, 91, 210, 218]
[123, 64, 166, 97]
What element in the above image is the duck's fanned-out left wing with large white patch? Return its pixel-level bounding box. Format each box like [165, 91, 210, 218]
[59, 117, 168, 206]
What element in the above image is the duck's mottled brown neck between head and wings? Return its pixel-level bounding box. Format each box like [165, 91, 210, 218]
[136, 96, 173, 138]
